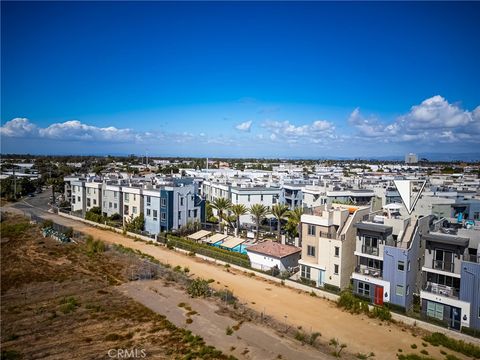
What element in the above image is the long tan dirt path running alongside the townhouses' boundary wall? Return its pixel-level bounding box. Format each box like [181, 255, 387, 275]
[1, 207, 472, 359]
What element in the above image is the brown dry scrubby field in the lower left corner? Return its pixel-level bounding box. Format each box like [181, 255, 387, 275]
[1, 217, 232, 360]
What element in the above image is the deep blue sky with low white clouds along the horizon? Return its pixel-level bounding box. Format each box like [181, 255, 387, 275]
[1, 2, 480, 157]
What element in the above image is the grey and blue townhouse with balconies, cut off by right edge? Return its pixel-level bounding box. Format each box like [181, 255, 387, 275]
[420, 229, 480, 330]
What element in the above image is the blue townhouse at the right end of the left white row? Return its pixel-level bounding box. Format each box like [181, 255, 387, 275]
[143, 179, 205, 234]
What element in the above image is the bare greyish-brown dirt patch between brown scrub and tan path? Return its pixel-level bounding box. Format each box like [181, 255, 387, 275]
[117, 280, 332, 360]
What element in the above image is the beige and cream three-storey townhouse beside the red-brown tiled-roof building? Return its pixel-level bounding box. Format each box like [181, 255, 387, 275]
[299, 204, 369, 289]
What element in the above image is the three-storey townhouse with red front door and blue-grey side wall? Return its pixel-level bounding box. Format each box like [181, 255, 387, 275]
[352, 204, 431, 310]
